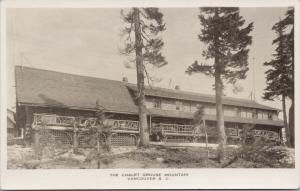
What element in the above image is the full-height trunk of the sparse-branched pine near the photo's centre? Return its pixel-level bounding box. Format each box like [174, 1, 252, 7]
[134, 8, 149, 147]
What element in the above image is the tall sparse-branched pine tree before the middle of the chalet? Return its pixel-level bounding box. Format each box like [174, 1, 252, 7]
[121, 8, 167, 146]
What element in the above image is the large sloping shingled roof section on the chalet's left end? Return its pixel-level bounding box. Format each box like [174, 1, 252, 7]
[15, 66, 137, 113]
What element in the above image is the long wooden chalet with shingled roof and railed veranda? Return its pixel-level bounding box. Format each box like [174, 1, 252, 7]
[15, 66, 283, 145]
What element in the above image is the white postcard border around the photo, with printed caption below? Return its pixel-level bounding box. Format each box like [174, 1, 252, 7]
[1, 0, 300, 190]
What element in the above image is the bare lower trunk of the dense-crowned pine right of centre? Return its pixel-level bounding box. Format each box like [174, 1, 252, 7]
[215, 59, 226, 162]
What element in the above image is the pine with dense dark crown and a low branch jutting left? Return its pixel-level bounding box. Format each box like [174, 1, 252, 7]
[186, 7, 253, 162]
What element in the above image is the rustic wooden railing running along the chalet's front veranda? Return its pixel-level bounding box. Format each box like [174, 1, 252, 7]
[32, 114, 280, 139]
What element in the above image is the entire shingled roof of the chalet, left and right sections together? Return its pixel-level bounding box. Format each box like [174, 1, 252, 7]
[15, 66, 278, 114]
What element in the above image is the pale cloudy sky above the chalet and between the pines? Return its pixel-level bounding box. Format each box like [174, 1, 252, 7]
[6, 7, 287, 116]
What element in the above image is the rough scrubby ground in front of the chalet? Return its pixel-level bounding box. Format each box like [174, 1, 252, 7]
[8, 145, 294, 169]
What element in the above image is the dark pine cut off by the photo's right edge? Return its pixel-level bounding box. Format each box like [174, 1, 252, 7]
[263, 8, 294, 146]
